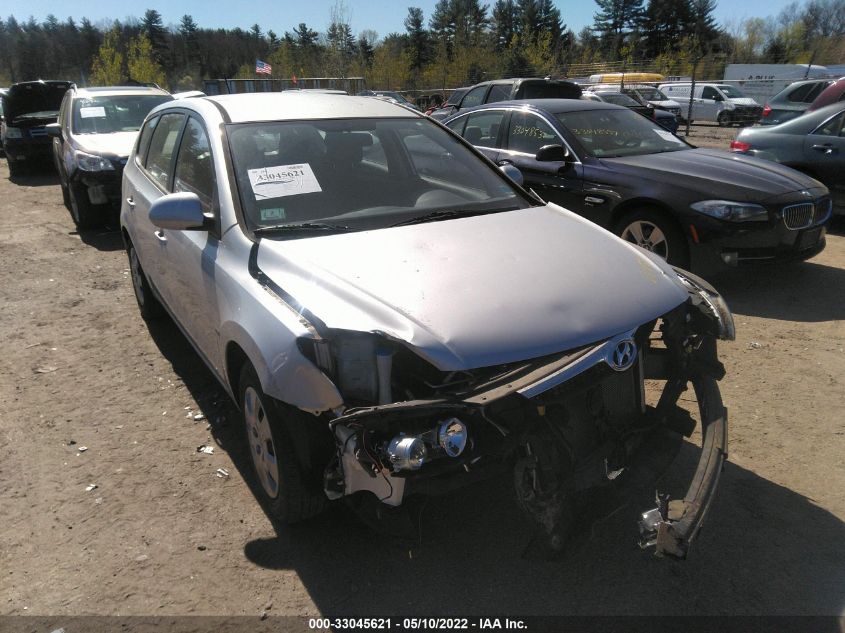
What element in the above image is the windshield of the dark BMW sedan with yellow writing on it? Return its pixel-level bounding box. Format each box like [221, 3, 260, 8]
[557, 110, 690, 158]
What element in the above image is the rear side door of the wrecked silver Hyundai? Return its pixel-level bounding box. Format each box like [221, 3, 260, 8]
[123, 112, 187, 294]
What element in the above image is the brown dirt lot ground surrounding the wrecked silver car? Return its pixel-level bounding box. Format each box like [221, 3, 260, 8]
[0, 141, 845, 620]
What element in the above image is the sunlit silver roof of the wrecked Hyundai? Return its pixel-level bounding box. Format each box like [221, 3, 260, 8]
[202, 91, 423, 123]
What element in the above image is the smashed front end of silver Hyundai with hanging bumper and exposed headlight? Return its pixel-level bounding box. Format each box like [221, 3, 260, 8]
[300, 271, 733, 558]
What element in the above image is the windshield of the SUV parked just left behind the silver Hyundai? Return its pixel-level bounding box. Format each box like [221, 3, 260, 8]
[73, 95, 173, 134]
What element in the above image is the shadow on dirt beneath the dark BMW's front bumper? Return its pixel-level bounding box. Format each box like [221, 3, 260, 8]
[710, 261, 845, 322]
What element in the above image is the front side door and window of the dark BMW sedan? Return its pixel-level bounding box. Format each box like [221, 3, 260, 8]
[497, 110, 584, 213]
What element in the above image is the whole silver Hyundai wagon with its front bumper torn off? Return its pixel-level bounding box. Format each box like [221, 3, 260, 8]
[121, 93, 733, 556]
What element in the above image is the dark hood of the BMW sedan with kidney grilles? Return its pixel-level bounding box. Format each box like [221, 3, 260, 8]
[601, 149, 818, 202]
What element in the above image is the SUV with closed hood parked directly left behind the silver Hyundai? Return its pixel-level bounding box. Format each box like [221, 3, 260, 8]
[47, 86, 173, 229]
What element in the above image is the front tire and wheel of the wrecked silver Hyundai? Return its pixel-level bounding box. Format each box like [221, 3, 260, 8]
[239, 363, 330, 524]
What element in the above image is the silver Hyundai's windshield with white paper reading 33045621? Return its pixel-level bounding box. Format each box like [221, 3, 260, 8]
[227, 118, 530, 235]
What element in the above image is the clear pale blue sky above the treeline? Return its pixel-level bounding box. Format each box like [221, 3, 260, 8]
[11, 0, 803, 37]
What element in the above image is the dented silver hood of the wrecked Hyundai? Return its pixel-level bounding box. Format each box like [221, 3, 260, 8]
[256, 205, 687, 370]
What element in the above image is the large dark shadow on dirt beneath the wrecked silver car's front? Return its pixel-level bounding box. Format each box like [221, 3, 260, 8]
[244, 445, 845, 616]
